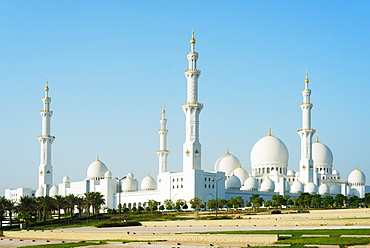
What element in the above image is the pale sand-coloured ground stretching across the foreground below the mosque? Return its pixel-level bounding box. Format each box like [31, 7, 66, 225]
[0, 209, 370, 247]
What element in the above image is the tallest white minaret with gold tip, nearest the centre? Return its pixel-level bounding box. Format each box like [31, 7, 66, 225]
[182, 29, 203, 171]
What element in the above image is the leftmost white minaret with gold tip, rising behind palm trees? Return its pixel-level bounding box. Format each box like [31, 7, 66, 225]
[37, 82, 55, 195]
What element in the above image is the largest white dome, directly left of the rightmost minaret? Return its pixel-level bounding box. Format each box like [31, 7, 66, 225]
[251, 135, 289, 167]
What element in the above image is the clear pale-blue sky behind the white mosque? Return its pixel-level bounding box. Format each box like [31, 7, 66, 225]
[0, 0, 370, 194]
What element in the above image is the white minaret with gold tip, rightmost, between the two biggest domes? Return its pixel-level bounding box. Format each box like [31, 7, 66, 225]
[298, 72, 316, 184]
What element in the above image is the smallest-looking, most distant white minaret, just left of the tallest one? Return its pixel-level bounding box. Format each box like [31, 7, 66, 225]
[157, 107, 170, 173]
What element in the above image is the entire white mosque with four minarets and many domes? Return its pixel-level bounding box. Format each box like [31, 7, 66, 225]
[5, 32, 370, 208]
